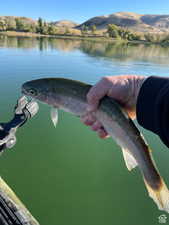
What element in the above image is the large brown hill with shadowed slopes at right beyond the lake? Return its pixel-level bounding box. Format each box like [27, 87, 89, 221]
[76, 12, 169, 32]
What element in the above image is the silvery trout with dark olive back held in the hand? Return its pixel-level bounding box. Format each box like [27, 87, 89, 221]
[21, 78, 169, 213]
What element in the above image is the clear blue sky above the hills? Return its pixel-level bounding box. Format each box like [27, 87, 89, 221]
[0, 0, 169, 23]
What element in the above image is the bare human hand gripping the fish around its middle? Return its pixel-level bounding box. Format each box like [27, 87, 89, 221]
[81, 75, 145, 138]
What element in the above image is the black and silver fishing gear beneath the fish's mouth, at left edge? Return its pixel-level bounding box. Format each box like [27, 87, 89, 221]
[0, 96, 39, 152]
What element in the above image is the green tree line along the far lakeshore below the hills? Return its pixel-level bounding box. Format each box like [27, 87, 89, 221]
[0, 17, 169, 44]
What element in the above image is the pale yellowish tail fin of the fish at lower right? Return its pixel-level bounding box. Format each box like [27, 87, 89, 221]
[143, 178, 169, 213]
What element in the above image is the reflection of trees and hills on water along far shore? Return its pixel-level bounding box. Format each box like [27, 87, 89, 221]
[0, 35, 169, 64]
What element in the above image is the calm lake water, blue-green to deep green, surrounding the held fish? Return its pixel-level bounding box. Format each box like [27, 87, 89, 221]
[0, 36, 169, 225]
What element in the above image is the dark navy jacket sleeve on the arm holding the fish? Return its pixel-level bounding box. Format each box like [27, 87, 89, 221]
[136, 76, 169, 147]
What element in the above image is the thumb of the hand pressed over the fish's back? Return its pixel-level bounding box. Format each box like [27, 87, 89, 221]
[87, 78, 109, 111]
